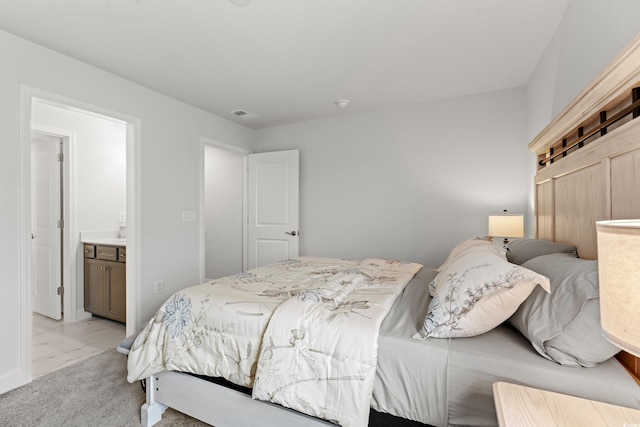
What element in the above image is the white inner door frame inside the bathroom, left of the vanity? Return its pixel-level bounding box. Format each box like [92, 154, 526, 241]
[29, 123, 74, 323]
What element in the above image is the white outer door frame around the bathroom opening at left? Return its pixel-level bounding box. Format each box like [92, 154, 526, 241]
[18, 84, 142, 383]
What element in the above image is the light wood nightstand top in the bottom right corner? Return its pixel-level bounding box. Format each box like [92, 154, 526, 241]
[493, 382, 640, 427]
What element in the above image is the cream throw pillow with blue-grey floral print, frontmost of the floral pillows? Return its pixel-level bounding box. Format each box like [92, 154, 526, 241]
[413, 248, 549, 339]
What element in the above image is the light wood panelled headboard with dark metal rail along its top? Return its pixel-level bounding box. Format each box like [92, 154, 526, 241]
[529, 36, 640, 382]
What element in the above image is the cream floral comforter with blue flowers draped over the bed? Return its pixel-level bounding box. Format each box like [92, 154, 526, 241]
[128, 257, 422, 426]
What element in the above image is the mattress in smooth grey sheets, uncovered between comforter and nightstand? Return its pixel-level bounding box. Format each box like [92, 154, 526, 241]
[371, 268, 640, 426]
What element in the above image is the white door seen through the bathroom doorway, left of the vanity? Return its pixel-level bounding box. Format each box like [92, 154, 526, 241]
[31, 132, 62, 320]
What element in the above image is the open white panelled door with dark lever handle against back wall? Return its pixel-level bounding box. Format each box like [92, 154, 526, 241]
[247, 150, 300, 268]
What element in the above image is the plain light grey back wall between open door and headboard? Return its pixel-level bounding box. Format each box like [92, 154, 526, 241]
[252, 89, 531, 266]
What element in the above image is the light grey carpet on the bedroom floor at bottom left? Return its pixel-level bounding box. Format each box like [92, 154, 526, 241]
[0, 350, 207, 427]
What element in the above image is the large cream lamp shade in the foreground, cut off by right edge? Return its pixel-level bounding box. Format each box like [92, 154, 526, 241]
[596, 220, 640, 357]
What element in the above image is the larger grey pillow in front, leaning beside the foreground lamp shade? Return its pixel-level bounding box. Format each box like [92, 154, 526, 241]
[509, 254, 620, 367]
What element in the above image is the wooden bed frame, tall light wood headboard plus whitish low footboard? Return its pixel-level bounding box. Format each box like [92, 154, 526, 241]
[141, 33, 640, 427]
